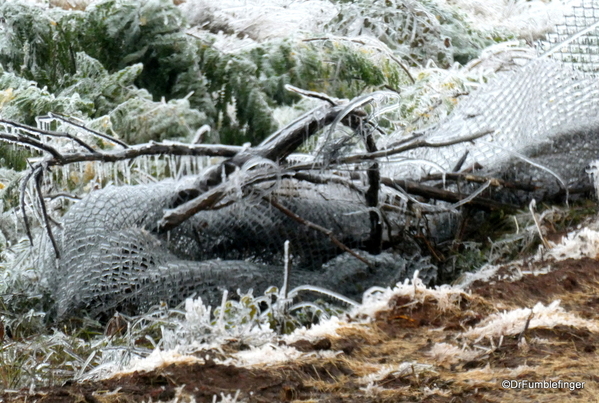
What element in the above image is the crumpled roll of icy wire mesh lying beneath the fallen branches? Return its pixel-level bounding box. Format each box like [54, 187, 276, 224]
[44, 181, 434, 319]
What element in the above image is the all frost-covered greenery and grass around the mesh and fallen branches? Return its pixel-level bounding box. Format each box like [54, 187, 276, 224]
[0, 0, 592, 394]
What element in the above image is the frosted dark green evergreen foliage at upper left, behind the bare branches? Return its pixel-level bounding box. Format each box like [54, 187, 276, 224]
[0, 0, 407, 144]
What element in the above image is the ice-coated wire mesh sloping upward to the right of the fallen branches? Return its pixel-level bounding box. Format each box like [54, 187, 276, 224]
[393, 60, 599, 194]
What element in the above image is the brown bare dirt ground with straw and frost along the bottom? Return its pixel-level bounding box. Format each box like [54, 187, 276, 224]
[0, 258, 599, 403]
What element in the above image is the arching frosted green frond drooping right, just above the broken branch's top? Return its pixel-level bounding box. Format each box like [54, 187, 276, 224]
[200, 34, 407, 144]
